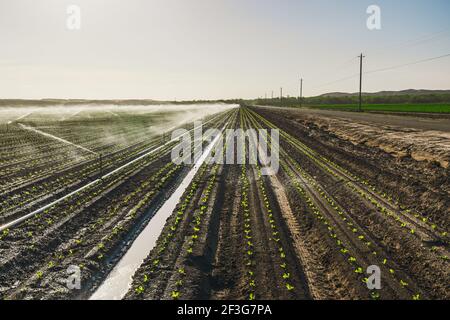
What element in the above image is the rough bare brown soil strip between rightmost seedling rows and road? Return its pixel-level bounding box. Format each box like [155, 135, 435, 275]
[251, 108, 450, 231]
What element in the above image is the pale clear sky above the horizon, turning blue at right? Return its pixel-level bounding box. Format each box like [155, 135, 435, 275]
[0, 0, 450, 100]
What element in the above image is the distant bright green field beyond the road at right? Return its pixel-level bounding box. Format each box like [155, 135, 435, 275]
[308, 104, 450, 113]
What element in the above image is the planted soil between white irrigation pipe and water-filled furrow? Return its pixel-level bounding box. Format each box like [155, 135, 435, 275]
[0, 112, 232, 299]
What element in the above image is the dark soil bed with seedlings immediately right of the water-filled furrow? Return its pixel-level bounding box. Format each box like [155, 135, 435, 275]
[125, 114, 235, 299]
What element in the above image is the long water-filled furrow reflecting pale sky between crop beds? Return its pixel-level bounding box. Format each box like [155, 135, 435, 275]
[90, 125, 226, 300]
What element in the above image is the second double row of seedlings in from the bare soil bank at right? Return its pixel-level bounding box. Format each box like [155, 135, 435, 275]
[246, 109, 426, 300]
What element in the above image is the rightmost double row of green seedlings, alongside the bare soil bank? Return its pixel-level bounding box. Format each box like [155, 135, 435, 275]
[250, 107, 448, 242]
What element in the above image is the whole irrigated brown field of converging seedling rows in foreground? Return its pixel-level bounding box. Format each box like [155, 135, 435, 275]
[0, 104, 450, 300]
